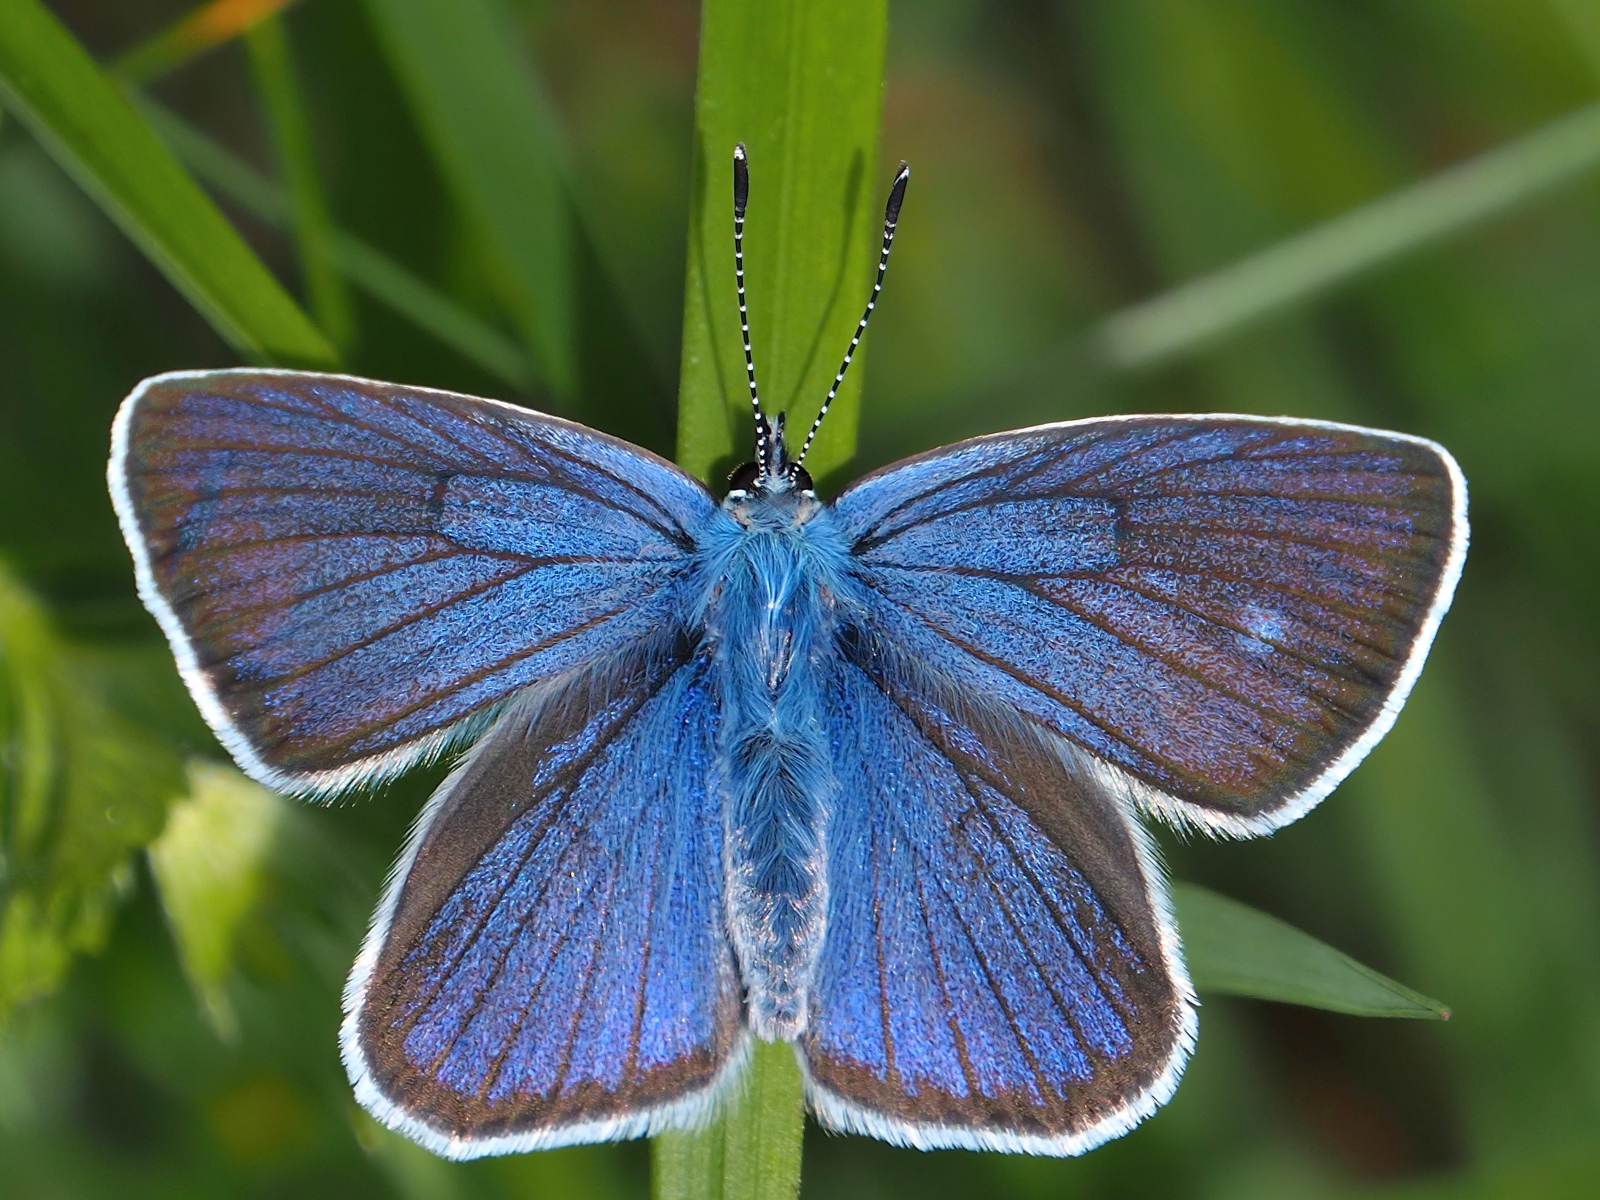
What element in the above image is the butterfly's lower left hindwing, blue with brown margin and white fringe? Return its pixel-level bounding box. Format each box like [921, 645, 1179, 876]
[341, 646, 746, 1158]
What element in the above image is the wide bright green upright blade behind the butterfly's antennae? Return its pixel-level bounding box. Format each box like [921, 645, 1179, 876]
[678, 0, 896, 480]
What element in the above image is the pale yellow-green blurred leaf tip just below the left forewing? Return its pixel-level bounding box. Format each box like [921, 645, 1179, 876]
[149, 762, 285, 1042]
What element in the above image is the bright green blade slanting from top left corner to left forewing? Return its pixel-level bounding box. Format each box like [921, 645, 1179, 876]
[0, 0, 338, 366]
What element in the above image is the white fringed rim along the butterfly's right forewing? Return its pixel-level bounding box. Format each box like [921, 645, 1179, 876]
[835, 413, 1470, 838]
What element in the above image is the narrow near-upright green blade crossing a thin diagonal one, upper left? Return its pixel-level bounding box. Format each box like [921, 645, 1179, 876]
[245, 16, 355, 349]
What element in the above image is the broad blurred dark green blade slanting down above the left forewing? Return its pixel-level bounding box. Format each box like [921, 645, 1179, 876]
[366, 0, 578, 397]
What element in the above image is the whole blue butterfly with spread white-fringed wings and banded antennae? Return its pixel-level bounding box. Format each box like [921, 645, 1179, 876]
[109, 150, 1467, 1158]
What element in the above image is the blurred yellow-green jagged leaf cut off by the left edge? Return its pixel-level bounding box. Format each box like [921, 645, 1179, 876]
[0, 568, 182, 1022]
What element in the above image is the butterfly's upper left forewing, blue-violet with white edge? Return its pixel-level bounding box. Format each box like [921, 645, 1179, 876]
[109, 371, 715, 792]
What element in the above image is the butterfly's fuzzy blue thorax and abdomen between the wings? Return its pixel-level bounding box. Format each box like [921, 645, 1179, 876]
[699, 488, 850, 1038]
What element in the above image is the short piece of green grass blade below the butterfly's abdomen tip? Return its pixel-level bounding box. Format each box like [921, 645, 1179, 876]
[651, 1042, 805, 1200]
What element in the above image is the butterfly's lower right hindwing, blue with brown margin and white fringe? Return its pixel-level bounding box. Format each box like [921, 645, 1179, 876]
[802, 648, 1195, 1154]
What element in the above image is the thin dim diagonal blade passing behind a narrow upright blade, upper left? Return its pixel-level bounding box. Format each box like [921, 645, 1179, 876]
[139, 98, 533, 392]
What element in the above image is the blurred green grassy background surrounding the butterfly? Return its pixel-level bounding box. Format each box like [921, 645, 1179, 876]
[0, 0, 1600, 1200]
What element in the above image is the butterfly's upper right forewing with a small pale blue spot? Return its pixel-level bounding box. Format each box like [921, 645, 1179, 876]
[835, 416, 1467, 834]
